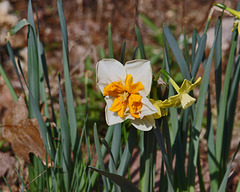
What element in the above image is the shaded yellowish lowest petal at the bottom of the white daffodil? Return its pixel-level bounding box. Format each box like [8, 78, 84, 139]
[130, 115, 155, 131]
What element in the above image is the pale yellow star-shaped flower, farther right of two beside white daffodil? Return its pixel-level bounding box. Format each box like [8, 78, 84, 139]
[168, 77, 201, 109]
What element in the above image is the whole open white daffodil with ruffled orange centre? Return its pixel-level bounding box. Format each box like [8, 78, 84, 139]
[96, 59, 157, 131]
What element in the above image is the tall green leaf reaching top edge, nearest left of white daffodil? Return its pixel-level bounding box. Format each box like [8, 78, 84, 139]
[57, 0, 78, 153]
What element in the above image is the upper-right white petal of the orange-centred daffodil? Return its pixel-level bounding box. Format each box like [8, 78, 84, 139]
[125, 59, 152, 96]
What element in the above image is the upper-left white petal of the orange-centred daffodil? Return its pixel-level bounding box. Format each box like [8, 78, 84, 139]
[96, 59, 126, 91]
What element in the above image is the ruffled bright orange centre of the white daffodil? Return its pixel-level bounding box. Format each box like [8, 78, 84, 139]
[103, 74, 144, 118]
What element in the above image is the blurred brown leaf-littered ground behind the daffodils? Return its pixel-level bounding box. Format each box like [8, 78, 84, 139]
[0, 0, 240, 191]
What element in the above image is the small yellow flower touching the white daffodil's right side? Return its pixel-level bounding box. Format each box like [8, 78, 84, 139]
[149, 99, 173, 119]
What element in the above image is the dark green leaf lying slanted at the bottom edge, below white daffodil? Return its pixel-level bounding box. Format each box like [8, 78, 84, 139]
[90, 167, 140, 192]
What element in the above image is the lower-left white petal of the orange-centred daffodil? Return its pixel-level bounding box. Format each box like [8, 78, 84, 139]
[105, 97, 125, 125]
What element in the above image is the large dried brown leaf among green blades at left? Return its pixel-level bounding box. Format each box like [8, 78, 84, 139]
[3, 95, 49, 162]
